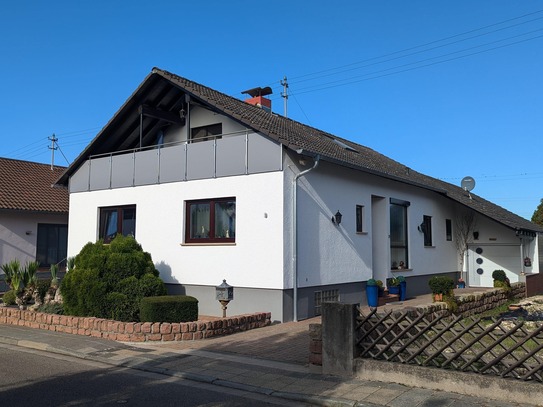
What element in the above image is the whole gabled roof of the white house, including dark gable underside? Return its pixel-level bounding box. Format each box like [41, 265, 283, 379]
[57, 68, 543, 233]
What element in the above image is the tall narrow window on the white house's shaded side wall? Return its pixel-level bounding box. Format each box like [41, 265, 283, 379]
[390, 198, 410, 269]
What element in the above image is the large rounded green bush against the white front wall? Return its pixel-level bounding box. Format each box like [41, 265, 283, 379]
[60, 235, 166, 321]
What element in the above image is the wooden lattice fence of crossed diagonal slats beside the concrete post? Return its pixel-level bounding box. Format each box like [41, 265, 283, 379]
[356, 309, 543, 382]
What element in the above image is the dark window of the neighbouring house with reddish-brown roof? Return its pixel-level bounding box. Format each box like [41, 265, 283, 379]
[36, 223, 68, 267]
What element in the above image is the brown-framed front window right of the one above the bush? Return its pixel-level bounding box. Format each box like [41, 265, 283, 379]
[185, 198, 236, 243]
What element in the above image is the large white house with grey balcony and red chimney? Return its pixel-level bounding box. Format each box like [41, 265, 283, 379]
[53, 68, 543, 321]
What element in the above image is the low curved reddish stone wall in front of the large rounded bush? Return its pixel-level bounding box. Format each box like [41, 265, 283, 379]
[0, 307, 271, 342]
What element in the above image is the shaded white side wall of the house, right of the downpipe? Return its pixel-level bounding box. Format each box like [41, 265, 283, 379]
[287, 158, 472, 287]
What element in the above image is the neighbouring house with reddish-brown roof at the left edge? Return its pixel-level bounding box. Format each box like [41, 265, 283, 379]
[0, 158, 69, 291]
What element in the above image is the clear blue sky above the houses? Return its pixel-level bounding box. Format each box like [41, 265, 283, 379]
[0, 0, 543, 219]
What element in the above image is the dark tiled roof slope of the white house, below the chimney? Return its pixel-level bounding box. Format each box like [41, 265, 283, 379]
[153, 68, 543, 233]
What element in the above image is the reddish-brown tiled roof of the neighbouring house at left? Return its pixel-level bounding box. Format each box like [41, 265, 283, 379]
[0, 158, 68, 214]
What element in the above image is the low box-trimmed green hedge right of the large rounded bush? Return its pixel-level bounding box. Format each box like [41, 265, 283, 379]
[140, 295, 198, 322]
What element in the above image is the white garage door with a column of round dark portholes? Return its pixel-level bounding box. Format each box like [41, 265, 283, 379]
[468, 245, 522, 287]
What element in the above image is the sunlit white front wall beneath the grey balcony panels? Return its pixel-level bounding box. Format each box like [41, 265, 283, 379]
[68, 172, 284, 289]
